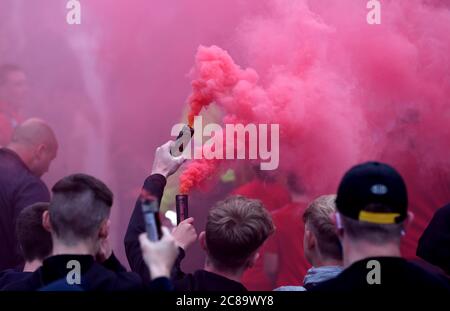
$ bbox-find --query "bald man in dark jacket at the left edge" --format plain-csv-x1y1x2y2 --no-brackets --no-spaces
0,119,58,271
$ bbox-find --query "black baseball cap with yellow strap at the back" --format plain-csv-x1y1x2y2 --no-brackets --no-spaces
336,162,408,224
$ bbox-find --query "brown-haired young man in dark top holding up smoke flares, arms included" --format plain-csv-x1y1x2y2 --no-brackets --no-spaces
124,142,274,291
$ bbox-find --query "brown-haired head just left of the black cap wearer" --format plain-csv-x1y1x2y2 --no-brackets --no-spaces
303,195,342,261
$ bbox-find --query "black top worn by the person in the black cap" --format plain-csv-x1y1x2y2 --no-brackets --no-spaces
310,257,450,293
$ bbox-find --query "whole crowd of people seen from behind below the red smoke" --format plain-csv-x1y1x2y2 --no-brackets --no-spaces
0,66,450,292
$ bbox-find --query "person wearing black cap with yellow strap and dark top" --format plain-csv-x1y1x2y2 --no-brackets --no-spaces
311,162,450,298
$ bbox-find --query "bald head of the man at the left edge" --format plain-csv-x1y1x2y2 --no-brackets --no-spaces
8,118,58,176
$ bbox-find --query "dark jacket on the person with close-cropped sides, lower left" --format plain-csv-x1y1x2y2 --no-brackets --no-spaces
5,254,171,291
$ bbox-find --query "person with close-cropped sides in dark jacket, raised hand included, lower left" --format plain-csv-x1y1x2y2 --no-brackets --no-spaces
5,174,178,291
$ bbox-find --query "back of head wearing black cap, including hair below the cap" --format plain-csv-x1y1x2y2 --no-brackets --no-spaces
336,162,408,245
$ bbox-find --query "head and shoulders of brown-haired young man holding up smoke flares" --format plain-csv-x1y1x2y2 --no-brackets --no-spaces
174,196,274,291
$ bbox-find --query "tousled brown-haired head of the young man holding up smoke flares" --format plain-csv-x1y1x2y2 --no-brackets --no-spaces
205,196,274,270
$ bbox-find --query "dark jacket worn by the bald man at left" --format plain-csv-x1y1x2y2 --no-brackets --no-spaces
0,148,50,271
